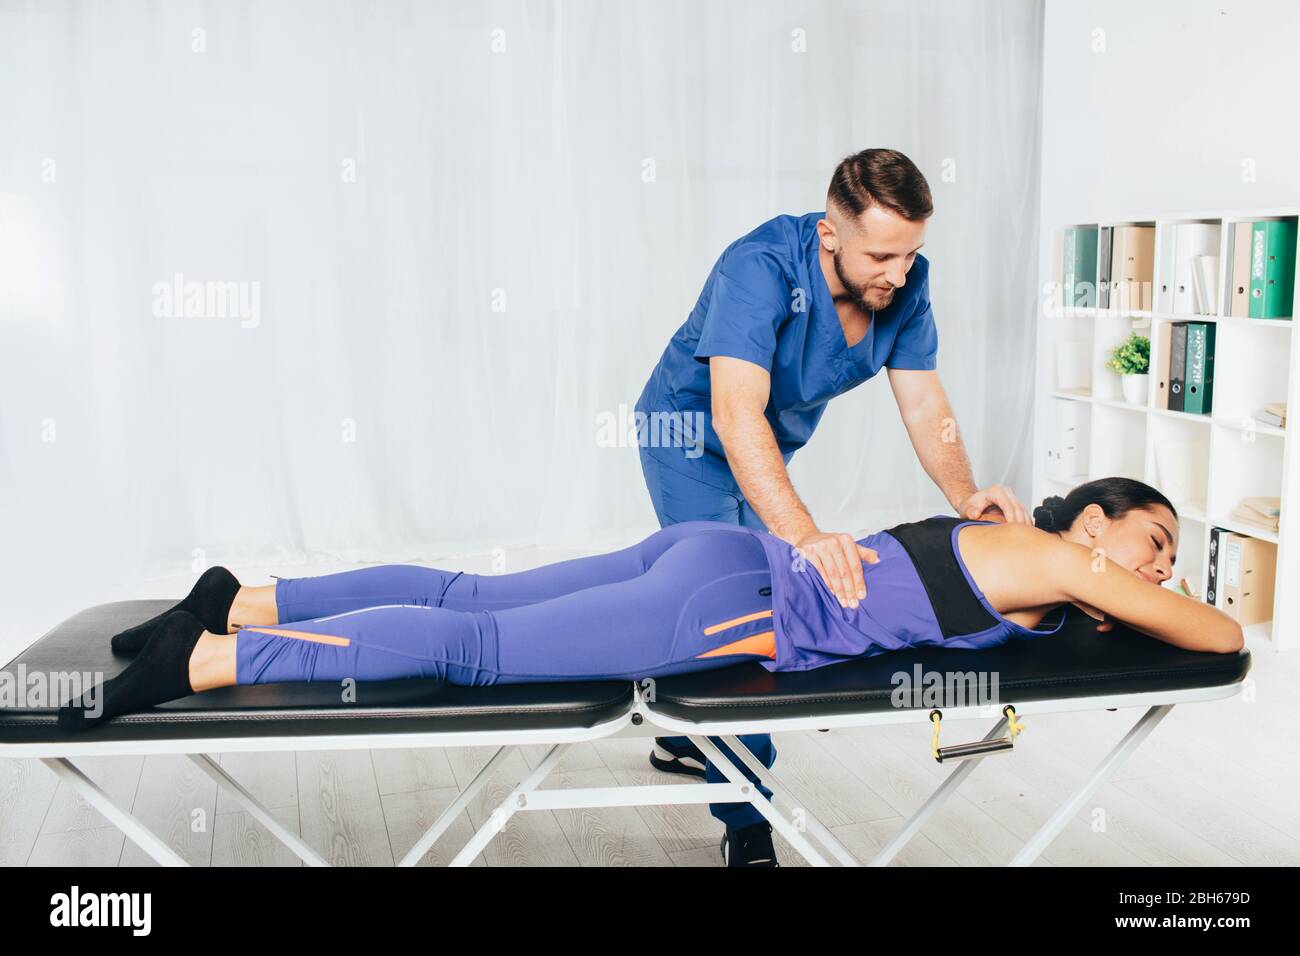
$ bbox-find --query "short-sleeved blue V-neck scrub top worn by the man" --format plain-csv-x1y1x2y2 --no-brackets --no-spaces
636,212,939,486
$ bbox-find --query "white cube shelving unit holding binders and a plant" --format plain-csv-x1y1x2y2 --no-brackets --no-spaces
1034,207,1300,650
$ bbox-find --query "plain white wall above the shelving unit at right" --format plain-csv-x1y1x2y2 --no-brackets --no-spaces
1035,0,1300,502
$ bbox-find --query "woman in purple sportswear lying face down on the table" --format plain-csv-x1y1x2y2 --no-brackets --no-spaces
59,477,1243,728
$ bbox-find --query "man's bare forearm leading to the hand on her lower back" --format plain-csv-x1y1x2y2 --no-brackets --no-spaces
714,415,816,544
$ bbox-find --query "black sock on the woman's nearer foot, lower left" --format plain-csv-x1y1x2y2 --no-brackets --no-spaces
59,611,204,731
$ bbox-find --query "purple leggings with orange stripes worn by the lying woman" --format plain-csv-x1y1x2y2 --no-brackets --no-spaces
235,522,775,685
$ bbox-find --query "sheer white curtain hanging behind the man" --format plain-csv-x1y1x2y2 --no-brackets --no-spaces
0,0,1043,647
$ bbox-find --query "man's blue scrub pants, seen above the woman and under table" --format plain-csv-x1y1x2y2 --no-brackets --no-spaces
640,445,776,829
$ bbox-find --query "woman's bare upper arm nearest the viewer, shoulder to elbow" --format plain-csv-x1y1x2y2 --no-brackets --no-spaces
1019,528,1245,654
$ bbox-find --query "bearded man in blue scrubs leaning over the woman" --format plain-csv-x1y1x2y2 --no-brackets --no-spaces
636,150,1032,866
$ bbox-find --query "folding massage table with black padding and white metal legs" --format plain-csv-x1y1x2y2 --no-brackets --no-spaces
0,601,1251,866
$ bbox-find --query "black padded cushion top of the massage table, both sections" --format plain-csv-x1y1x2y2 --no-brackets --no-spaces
0,601,1251,743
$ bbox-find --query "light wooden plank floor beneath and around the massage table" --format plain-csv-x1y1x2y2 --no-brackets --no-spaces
0,553,1300,866
